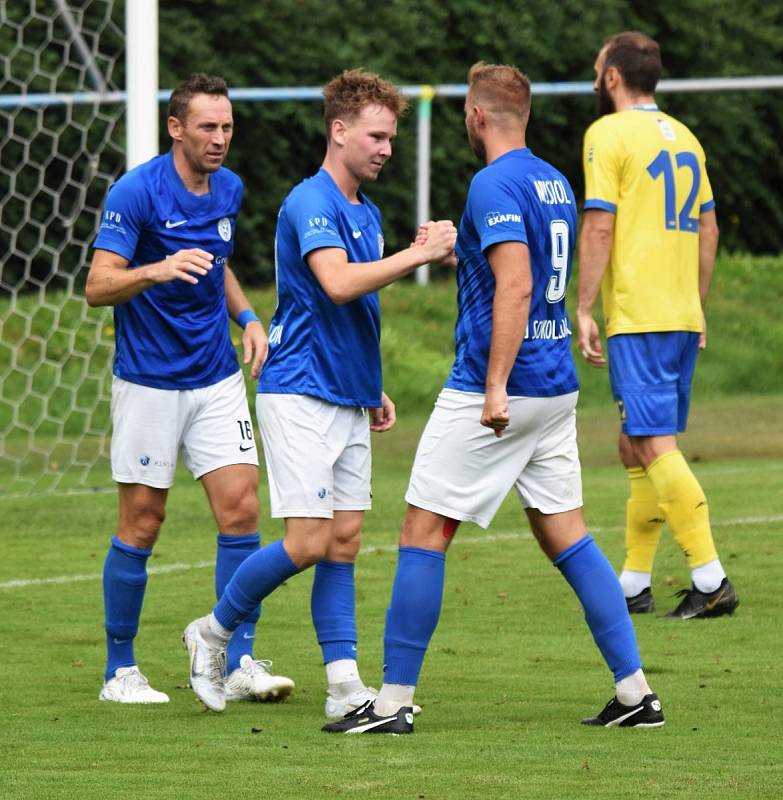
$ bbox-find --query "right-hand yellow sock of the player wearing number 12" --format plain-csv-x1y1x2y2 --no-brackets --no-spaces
648,450,718,569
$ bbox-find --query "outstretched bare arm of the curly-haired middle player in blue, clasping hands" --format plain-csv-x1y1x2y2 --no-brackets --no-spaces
305,220,457,305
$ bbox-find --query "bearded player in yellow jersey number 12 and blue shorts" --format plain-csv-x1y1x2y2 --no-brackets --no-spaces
576,32,739,619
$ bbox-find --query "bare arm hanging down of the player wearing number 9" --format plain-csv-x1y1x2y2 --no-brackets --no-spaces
481,242,533,437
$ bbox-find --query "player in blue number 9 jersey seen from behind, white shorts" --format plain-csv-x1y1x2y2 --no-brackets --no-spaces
323,63,664,734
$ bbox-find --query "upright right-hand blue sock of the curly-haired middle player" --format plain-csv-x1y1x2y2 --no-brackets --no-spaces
310,561,357,664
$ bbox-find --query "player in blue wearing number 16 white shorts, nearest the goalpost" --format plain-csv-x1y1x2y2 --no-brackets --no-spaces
86,74,294,703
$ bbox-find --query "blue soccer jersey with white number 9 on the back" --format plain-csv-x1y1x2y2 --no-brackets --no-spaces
446,148,579,397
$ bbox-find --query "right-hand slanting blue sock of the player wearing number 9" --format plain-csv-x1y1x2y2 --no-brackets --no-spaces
554,536,642,683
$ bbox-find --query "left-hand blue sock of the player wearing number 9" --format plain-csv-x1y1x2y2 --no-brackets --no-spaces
383,547,448,686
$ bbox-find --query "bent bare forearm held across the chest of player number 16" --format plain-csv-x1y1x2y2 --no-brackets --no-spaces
84,247,212,306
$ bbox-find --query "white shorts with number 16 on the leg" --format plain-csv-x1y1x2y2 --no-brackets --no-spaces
111,372,258,489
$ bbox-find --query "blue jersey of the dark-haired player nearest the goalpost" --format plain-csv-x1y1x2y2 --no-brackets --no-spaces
94,153,243,389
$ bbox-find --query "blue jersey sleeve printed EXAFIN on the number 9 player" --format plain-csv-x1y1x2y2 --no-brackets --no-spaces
466,169,527,253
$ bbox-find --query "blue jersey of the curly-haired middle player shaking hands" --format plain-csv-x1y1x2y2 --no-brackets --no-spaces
258,169,383,408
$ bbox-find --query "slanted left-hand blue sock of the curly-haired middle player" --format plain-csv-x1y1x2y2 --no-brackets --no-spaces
213,539,301,631
